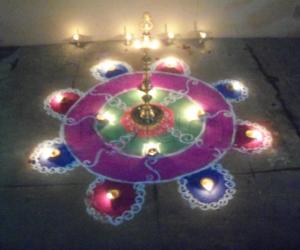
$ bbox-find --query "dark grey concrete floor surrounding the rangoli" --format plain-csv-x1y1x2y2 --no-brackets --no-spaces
0,39,300,250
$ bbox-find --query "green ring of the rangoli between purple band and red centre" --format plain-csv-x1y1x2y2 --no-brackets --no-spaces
95,88,205,157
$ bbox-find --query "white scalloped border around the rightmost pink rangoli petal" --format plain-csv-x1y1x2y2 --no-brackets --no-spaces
232,120,273,154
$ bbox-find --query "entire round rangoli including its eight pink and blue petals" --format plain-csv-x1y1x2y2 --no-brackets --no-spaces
29,52,272,226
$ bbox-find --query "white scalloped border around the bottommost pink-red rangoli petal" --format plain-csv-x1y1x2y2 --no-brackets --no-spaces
84,178,146,226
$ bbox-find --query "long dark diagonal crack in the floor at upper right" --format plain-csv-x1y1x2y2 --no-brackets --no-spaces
246,44,300,138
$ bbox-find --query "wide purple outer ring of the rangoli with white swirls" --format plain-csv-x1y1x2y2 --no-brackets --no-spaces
61,72,236,183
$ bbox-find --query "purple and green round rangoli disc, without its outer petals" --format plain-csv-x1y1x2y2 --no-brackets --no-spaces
62,73,235,183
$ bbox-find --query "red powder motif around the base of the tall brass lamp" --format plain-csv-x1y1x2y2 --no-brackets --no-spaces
121,104,174,137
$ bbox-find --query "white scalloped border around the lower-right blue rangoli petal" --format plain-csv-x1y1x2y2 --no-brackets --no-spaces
177,164,236,211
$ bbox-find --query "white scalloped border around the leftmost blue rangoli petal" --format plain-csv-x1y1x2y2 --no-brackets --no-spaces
29,138,80,174
